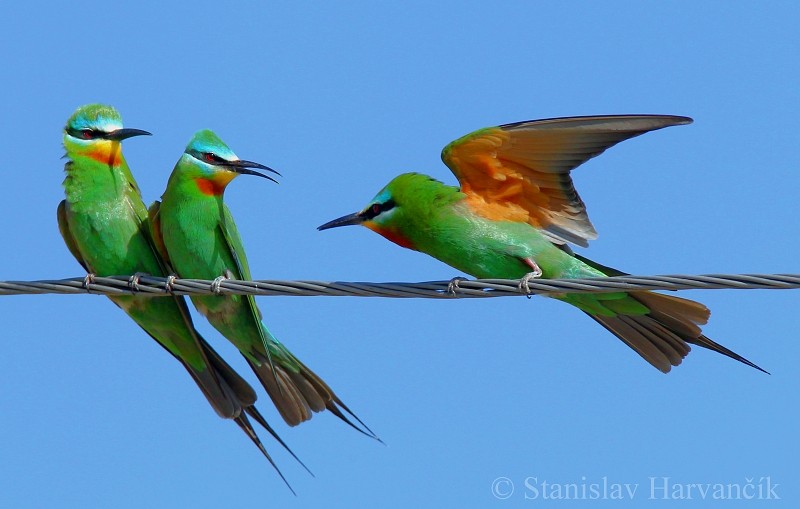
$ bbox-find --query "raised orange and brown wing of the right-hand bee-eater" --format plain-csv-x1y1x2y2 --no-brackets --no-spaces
442,115,692,246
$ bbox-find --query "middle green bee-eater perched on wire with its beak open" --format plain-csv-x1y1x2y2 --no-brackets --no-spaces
150,130,377,438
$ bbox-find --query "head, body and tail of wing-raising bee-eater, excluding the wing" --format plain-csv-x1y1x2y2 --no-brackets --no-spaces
320,171,761,373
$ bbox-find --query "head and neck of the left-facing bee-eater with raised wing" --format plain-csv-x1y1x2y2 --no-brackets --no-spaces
317,173,453,249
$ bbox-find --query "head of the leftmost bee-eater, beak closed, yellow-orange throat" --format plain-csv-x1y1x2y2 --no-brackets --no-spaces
64,104,150,165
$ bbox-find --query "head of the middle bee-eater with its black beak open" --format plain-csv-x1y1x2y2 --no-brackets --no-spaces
176,129,280,196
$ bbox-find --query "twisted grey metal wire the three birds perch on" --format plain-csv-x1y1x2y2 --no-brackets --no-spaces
0,274,800,299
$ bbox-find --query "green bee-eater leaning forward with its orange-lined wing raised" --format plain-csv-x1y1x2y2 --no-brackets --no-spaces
319,115,763,373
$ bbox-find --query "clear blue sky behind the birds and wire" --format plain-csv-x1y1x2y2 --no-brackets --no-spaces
0,1,800,508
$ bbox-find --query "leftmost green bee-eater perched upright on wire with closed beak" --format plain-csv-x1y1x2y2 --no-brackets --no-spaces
58,104,299,481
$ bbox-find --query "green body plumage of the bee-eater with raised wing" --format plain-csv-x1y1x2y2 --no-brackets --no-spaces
362,173,649,316
